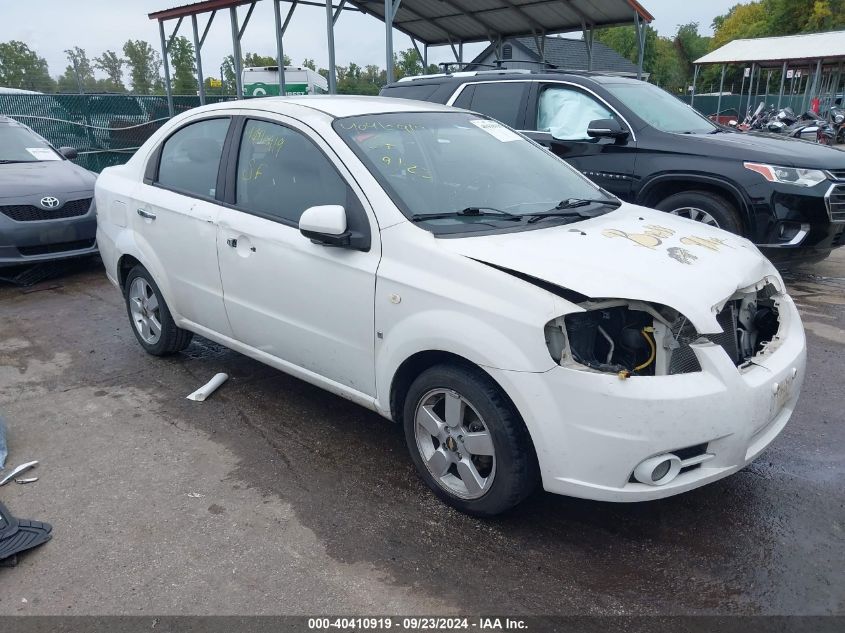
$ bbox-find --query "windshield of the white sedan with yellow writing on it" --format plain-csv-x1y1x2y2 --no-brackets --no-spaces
334,112,615,232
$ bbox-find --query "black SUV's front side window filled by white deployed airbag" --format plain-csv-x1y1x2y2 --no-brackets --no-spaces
537,86,616,141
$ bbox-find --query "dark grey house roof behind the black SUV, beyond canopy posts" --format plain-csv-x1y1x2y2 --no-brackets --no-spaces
472,37,637,74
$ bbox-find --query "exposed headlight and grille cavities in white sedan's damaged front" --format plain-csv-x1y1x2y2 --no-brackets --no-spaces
545,280,782,379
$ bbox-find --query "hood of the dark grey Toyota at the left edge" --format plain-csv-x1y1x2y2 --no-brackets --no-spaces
0,160,97,198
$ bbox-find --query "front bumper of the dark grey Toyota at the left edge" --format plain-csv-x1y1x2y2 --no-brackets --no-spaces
0,194,97,267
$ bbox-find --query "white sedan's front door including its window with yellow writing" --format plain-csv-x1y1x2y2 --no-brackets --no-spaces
218,119,380,396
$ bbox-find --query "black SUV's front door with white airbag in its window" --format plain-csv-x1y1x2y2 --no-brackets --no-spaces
526,83,636,199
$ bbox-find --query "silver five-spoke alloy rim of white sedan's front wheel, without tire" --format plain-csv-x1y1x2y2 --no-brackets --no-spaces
414,389,496,499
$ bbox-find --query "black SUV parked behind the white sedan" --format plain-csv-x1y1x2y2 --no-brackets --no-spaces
381,70,845,260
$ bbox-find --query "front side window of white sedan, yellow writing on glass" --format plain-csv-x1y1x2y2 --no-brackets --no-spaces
235,121,347,224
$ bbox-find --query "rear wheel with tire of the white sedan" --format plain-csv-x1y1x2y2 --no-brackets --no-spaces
124,265,194,356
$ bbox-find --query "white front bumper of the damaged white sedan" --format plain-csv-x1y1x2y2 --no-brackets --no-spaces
487,297,806,501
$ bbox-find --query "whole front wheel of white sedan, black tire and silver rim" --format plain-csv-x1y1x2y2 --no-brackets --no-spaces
403,364,538,516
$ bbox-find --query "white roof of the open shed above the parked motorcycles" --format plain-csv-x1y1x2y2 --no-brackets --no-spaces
693,31,845,66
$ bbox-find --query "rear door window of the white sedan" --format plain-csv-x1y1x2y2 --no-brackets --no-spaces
157,118,229,198
